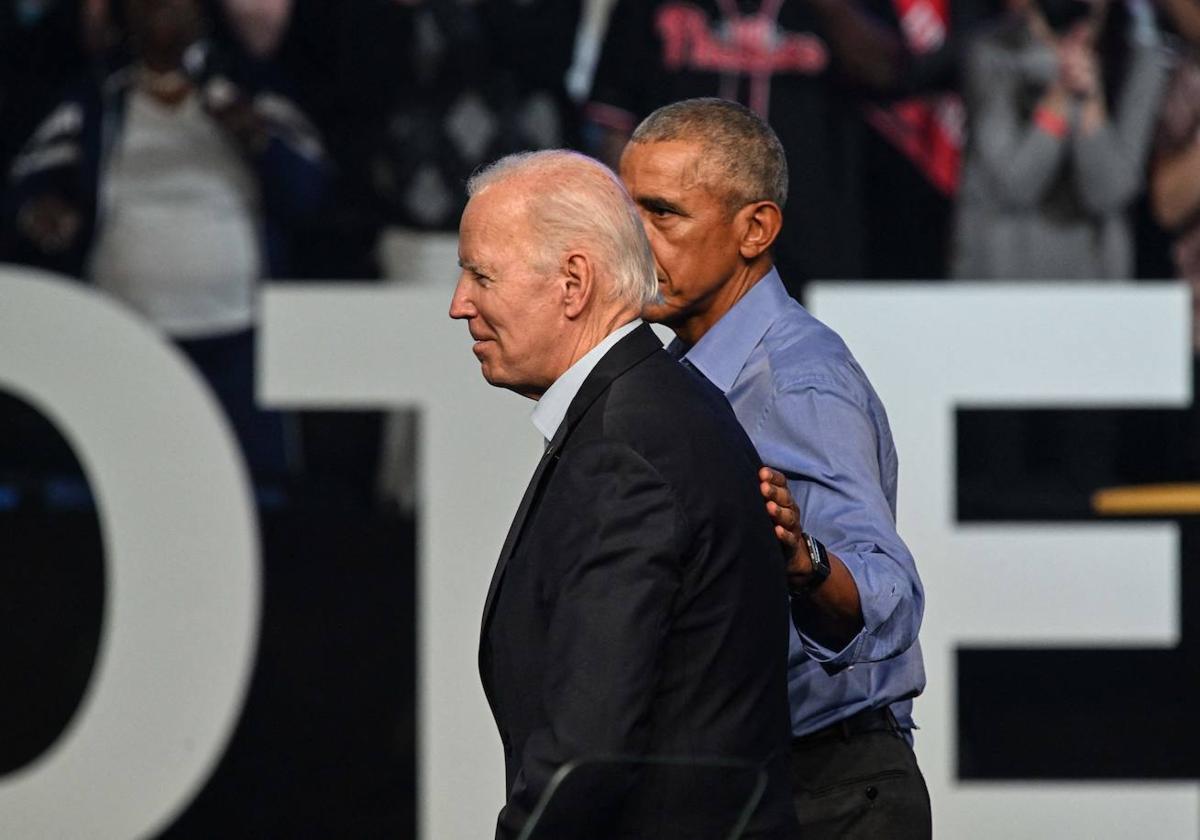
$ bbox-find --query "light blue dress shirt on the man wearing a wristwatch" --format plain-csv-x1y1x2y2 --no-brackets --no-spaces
670,270,925,736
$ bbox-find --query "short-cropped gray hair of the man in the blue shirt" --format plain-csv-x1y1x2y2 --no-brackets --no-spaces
630,97,787,209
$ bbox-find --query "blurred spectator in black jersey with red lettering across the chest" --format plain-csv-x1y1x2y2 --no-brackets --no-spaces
584,0,904,295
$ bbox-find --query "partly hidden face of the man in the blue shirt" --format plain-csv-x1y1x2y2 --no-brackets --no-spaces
620,140,739,326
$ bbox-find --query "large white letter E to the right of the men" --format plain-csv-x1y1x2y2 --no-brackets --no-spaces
812,283,1200,840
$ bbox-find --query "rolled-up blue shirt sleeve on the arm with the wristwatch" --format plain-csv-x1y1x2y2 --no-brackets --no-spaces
755,371,924,672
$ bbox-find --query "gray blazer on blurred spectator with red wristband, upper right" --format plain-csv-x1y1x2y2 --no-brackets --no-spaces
952,24,1168,280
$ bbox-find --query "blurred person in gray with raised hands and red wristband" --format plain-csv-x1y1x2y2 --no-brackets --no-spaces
953,0,1168,280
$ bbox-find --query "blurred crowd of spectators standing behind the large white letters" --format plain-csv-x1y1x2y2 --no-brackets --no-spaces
0,0,1200,506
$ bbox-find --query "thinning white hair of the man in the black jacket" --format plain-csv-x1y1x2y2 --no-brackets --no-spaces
467,149,659,311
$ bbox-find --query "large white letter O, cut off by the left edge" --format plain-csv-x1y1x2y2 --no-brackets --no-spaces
0,266,259,840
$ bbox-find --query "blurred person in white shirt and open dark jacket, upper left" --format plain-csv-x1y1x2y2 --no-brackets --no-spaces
5,0,329,476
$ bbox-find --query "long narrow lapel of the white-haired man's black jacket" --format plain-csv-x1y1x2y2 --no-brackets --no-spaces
480,324,662,648
